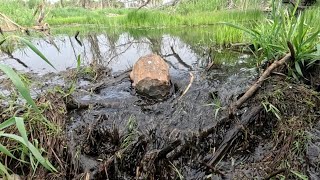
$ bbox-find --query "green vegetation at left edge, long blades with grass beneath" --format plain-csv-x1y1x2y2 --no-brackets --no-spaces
0,36,60,179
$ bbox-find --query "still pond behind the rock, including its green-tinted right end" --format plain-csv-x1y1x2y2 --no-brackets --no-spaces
3,28,252,74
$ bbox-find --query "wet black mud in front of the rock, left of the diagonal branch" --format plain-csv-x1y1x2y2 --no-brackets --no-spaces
67,61,256,179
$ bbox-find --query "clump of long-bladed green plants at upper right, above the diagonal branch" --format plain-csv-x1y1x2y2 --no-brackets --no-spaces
223,0,320,78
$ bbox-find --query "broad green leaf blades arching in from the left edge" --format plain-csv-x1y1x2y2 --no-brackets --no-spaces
0,36,57,178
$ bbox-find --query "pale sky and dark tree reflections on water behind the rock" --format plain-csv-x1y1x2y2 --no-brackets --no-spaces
0,33,251,74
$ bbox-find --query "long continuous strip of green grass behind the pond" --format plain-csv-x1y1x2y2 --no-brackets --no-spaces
47,8,263,28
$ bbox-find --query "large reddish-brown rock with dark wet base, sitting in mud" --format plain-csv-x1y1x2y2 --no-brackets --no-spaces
130,54,170,99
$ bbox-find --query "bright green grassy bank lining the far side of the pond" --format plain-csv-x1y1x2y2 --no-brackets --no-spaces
0,0,264,44
